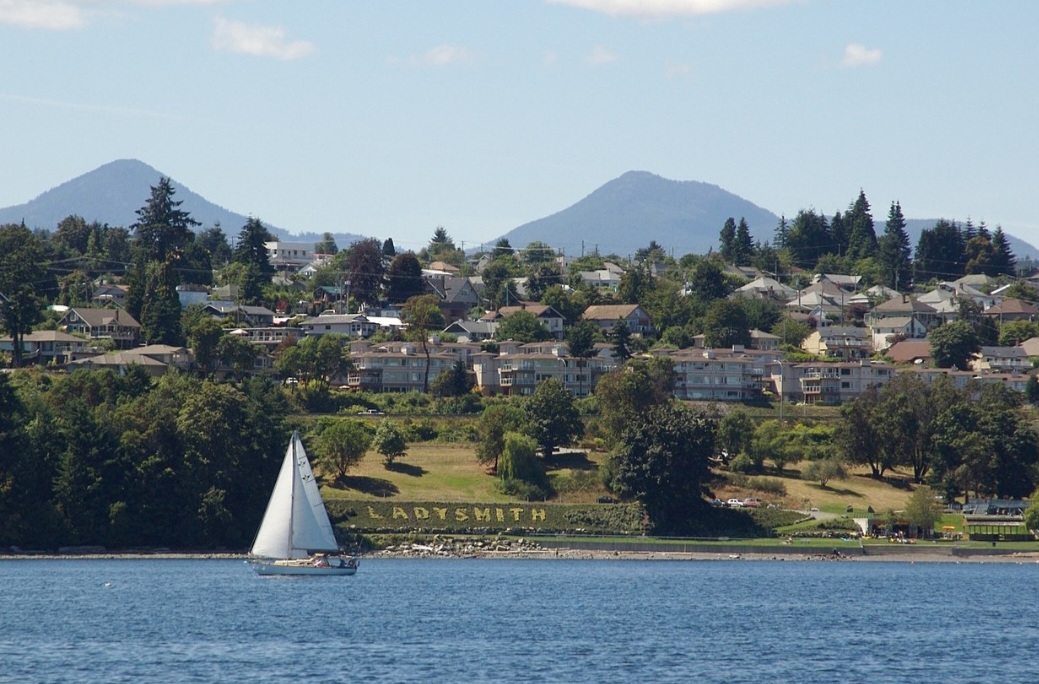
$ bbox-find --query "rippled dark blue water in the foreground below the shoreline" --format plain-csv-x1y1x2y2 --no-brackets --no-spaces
0,560,1039,684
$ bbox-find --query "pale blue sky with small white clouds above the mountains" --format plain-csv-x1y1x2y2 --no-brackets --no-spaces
0,0,1039,251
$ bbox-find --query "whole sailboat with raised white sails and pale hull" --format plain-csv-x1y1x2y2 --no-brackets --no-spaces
249,431,357,575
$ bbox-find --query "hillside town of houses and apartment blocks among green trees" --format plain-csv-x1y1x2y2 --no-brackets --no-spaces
6,185,1039,405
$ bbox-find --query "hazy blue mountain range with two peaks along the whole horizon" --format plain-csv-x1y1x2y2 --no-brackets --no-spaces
0,159,1039,260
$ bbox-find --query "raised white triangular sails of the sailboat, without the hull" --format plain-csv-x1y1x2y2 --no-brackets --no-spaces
251,432,339,558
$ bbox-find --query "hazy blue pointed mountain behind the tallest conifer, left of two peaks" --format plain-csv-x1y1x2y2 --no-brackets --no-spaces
0,159,363,246
